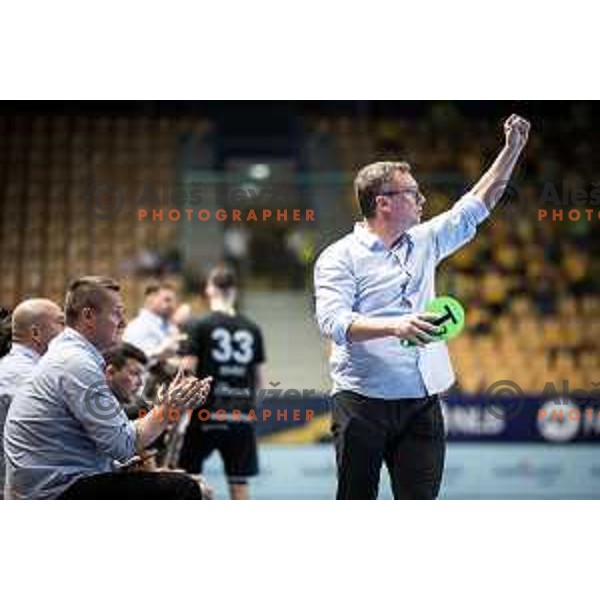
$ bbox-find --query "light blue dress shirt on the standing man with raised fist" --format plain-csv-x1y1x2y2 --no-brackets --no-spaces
314,195,489,400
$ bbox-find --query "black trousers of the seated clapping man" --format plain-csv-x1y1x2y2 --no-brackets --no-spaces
59,471,202,500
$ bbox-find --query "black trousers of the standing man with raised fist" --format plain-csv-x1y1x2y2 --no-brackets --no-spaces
332,391,446,500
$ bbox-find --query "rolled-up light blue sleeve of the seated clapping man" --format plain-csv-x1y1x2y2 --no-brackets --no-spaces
61,359,136,462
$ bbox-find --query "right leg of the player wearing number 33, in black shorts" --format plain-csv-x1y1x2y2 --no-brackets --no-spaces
219,423,258,500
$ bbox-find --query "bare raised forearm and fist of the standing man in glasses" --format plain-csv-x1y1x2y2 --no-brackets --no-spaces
470,115,530,210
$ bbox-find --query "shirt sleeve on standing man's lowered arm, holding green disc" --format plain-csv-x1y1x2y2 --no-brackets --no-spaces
314,247,358,346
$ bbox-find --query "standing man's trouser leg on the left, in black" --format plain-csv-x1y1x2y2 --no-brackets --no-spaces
331,392,387,500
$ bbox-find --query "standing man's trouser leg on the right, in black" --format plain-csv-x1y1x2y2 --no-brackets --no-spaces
385,397,446,500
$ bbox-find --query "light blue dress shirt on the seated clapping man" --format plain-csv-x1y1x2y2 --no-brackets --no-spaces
4,327,136,498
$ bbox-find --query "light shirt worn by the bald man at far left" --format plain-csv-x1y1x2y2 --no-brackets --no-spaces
0,342,40,498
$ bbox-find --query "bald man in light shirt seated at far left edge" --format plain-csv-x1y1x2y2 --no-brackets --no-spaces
0,298,65,499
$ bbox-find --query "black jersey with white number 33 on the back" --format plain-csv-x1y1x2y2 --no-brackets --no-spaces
184,311,265,414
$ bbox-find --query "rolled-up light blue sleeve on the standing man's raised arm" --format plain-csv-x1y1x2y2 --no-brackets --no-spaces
426,194,490,263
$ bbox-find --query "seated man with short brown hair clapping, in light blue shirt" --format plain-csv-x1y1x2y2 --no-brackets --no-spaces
4,277,210,499
